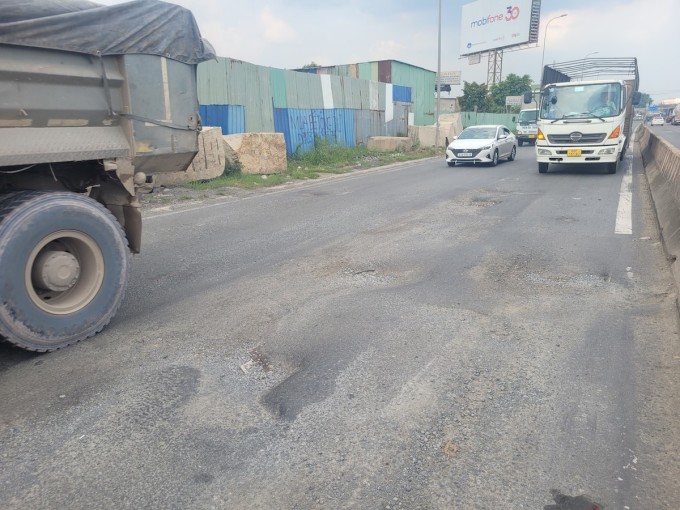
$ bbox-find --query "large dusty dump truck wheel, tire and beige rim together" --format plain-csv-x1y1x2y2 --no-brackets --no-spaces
0,191,130,352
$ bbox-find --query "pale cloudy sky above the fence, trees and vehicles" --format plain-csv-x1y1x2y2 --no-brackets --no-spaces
95,0,680,103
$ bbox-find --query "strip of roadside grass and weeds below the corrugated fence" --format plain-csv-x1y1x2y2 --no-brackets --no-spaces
186,140,442,190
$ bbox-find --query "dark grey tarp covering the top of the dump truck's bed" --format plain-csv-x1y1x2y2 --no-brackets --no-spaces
0,0,215,64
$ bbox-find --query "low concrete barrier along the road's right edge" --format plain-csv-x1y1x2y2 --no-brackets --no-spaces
636,125,680,294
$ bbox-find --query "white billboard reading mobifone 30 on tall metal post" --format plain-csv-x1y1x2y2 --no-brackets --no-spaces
460,0,541,57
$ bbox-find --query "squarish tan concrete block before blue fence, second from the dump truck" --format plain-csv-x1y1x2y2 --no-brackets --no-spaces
223,133,288,175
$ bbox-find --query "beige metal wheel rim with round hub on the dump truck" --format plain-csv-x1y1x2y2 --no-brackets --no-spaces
24,230,104,315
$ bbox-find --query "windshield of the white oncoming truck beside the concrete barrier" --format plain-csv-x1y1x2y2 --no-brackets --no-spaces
541,83,621,119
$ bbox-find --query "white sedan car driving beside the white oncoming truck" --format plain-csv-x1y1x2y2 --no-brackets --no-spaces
446,125,517,166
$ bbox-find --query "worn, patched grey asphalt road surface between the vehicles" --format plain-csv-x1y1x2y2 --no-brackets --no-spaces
0,137,680,510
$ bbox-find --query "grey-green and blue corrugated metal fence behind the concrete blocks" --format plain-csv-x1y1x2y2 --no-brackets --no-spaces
198,58,412,154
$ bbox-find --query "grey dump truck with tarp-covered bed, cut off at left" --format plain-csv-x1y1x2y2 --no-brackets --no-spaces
0,0,214,352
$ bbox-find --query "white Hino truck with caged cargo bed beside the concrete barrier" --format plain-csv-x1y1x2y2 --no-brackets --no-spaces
524,58,640,174
